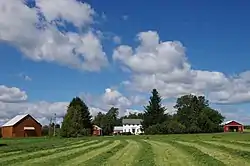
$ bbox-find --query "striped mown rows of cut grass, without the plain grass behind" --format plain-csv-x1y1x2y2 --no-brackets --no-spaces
0,137,250,166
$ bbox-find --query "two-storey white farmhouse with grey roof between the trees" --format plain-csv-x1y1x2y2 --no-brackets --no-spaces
122,119,142,135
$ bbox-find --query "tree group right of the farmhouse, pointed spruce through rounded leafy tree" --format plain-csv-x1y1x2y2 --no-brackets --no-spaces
142,89,225,134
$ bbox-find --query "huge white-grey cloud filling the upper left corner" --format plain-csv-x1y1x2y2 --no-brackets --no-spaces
0,0,108,71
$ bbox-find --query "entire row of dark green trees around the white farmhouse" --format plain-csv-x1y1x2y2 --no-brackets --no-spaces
60,89,224,137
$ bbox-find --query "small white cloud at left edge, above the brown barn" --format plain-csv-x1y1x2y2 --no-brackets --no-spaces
0,85,28,103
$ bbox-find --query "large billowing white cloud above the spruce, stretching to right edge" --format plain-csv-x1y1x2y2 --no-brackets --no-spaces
113,31,250,104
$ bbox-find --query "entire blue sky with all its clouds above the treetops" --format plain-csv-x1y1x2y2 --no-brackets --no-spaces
0,0,250,124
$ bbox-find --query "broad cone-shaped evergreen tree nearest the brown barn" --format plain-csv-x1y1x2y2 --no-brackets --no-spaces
60,97,92,137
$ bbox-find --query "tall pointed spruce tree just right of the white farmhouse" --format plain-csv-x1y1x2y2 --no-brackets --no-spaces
142,89,167,130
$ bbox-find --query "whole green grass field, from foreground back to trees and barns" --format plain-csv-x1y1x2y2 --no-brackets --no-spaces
0,133,250,166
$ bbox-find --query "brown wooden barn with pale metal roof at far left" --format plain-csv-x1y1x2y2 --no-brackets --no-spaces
1,114,42,138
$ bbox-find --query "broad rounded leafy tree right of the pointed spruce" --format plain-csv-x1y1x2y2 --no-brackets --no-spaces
175,95,224,133
